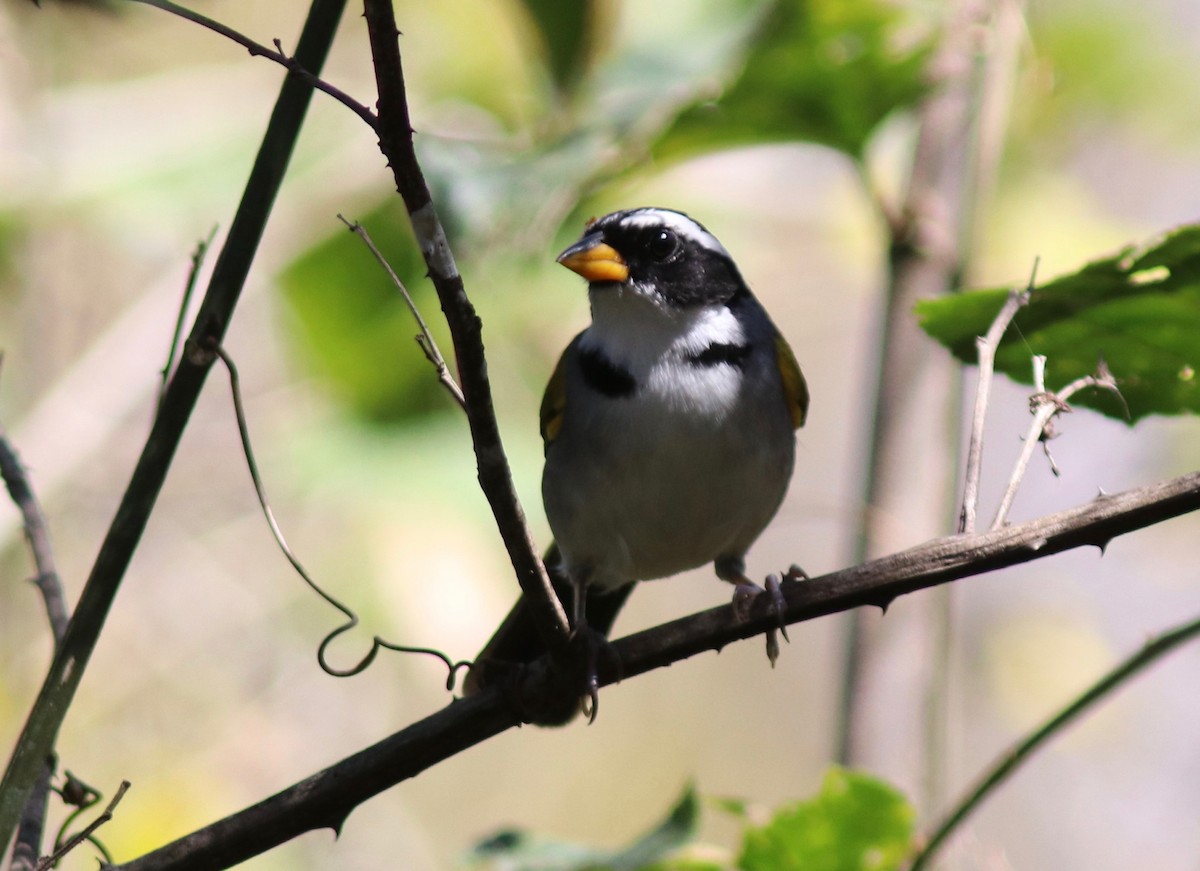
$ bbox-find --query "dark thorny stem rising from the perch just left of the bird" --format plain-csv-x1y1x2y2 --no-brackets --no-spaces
362,0,568,649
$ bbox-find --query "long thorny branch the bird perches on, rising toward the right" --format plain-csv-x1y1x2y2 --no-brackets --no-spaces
110,471,1200,871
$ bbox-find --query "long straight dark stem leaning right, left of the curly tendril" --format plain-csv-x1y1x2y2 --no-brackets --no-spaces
0,0,346,854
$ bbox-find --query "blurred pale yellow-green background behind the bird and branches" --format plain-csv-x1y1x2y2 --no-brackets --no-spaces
0,0,1200,871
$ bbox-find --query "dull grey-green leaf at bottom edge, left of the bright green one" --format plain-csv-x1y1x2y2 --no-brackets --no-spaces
468,786,710,871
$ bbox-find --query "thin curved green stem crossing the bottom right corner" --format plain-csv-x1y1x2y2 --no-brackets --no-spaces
908,619,1200,871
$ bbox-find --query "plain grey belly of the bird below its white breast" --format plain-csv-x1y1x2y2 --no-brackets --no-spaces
542,386,794,588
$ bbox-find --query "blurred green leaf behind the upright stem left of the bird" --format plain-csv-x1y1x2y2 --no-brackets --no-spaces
280,197,450,424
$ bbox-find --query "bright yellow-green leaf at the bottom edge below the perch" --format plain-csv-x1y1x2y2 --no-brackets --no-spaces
738,768,916,871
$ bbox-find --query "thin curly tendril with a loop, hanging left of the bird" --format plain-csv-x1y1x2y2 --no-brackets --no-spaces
214,347,470,690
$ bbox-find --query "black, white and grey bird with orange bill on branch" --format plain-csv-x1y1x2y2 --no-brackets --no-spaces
468,209,809,715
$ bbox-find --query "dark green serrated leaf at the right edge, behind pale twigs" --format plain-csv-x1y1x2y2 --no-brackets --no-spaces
917,224,1200,424
